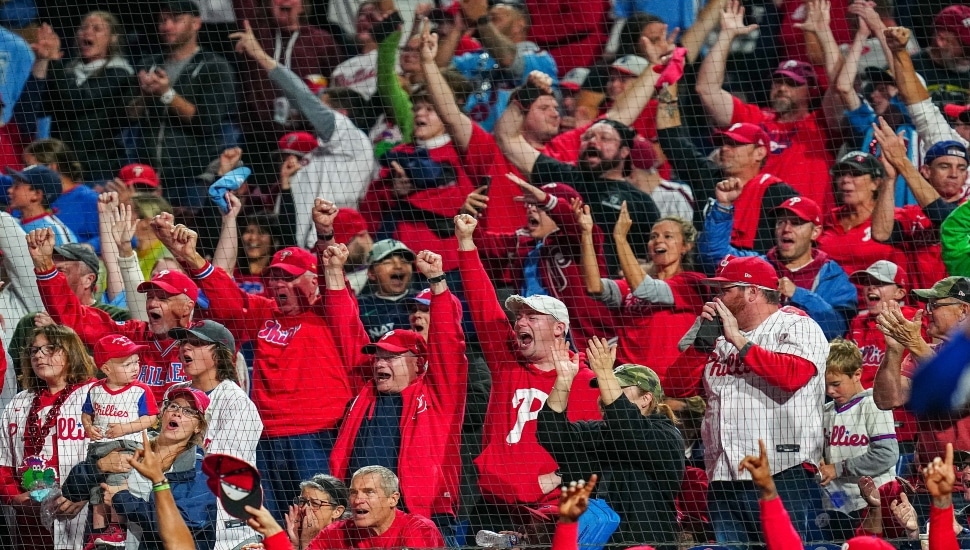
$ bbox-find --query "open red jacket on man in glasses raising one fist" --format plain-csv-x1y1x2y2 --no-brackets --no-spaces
330,292,468,517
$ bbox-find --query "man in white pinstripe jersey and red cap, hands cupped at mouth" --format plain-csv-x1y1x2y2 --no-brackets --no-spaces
666,257,829,544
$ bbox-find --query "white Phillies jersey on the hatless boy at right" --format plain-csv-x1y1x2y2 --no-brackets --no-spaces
822,389,898,514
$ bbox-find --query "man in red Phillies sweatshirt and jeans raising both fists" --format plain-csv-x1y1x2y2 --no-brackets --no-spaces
149,199,369,517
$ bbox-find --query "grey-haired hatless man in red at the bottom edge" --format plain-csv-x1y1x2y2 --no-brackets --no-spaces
307,466,445,550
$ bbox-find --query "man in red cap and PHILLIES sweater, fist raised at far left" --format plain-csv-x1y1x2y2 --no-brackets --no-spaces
27,228,191,402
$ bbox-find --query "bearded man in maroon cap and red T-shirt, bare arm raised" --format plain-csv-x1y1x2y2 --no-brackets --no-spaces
697,2,835,212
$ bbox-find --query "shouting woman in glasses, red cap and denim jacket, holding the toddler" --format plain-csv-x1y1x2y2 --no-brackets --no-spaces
64,388,216,550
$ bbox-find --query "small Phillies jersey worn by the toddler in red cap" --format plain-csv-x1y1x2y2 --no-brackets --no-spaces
81,379,158,443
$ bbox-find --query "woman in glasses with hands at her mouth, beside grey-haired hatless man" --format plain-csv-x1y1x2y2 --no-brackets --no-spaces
286,474,350,550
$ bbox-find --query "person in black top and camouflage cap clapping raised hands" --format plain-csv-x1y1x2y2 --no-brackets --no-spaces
536,337,684,549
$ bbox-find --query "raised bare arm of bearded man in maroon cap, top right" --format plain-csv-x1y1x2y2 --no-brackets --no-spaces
697,0,758,127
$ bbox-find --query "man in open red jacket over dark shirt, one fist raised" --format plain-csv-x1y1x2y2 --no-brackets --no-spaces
330,250,468,546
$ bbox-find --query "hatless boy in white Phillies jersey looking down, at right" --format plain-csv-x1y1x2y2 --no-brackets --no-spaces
819,338,899,540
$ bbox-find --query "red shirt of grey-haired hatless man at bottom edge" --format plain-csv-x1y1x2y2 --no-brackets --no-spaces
307,510,445,550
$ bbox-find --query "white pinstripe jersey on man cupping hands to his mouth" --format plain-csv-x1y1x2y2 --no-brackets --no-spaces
702,307,829,481
